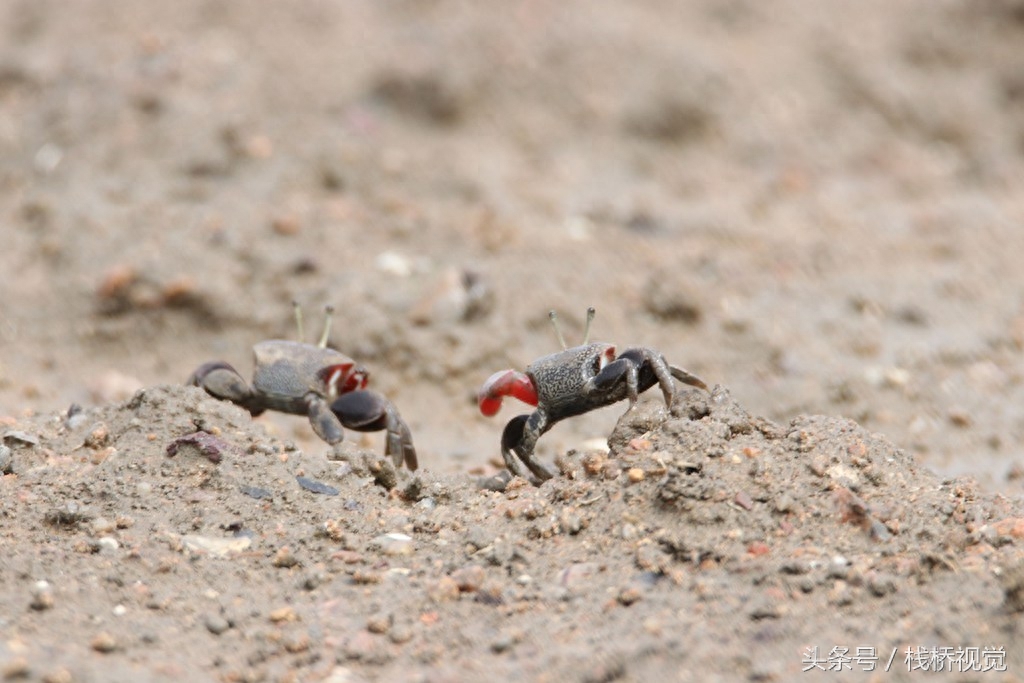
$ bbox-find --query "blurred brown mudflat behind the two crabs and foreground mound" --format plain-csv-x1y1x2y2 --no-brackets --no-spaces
0,0,1024,494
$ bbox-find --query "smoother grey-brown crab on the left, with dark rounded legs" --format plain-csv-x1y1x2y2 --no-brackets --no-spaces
187,304,417,470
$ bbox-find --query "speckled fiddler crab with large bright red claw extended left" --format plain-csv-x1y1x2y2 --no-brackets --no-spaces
477,308,708,483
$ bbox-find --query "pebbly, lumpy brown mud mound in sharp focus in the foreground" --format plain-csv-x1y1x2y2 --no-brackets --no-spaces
0,386,1024,682
